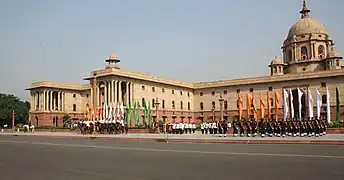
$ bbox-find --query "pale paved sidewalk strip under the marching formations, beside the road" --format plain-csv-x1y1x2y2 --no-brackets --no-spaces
0,132,344,145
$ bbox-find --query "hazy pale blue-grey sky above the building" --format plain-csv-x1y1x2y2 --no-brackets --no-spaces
0,0,344,99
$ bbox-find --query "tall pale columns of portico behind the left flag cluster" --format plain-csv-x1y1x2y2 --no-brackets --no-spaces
91,80,134,106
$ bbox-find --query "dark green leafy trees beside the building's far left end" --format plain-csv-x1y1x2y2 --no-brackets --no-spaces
0,93,30,126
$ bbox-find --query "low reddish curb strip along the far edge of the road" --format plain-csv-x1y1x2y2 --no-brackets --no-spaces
0,134,344,145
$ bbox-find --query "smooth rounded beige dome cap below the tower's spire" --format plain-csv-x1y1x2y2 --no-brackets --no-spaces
287,17,328,39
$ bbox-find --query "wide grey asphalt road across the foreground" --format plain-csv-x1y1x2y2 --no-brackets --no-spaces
0,136,344,180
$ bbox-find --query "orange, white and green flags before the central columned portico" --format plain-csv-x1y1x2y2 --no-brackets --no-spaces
85,102,153,127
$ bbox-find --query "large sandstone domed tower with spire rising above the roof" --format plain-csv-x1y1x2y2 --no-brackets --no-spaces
282,1,341,73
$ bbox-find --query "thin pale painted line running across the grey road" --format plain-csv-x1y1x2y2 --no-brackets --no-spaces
0,140,344,159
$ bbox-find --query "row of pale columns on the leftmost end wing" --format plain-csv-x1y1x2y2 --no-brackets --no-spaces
30,91,65,111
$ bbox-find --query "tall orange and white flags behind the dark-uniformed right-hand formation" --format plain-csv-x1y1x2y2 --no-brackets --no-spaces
237,87,340,122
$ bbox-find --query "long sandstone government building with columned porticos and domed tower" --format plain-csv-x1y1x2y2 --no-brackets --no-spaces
28,2,344,127
